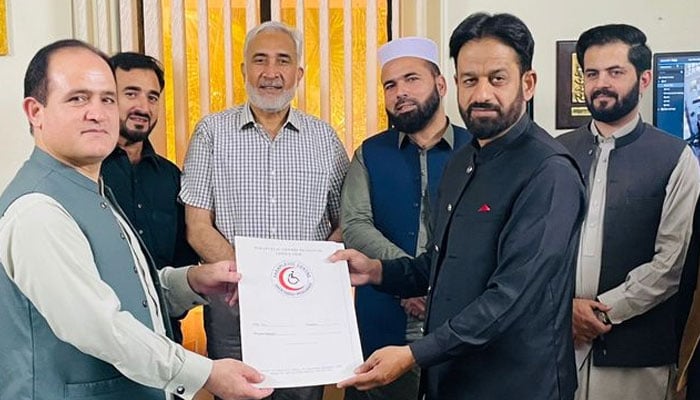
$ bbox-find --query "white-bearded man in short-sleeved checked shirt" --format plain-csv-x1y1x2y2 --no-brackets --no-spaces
180,21,349,400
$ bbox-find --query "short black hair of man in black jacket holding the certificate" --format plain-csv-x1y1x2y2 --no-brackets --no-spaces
450,13,535,74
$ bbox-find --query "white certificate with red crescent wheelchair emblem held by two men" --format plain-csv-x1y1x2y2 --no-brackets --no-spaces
236,236,362,388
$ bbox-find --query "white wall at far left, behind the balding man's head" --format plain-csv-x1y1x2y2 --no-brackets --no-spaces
0,0,71,191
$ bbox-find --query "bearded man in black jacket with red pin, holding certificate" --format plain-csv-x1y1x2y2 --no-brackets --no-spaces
335,14,585,400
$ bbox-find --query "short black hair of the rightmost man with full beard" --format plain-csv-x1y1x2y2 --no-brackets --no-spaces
576,24,651,77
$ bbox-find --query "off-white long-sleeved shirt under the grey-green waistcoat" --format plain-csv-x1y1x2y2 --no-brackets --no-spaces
0,193,212,399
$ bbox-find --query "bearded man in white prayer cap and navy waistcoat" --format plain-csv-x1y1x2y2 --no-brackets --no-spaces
341,37,471,400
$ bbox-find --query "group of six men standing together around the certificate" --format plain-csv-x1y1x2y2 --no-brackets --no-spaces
0,13,700,400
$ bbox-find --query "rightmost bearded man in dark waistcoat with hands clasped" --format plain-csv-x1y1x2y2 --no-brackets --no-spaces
559,25,700,400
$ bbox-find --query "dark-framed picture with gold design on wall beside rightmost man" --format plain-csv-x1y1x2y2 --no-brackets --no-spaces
555,40,591,129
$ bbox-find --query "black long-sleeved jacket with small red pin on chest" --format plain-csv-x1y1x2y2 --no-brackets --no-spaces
381,116,585,400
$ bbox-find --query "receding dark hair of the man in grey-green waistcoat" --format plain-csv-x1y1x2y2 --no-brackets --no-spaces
24,39,114,105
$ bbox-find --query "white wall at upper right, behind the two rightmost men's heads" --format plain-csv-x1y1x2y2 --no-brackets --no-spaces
438,0,700,135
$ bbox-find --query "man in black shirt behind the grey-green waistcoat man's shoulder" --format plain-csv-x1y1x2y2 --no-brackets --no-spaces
100,52,199,343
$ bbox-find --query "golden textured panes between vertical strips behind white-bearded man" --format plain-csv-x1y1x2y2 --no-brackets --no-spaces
161,0,388,161
